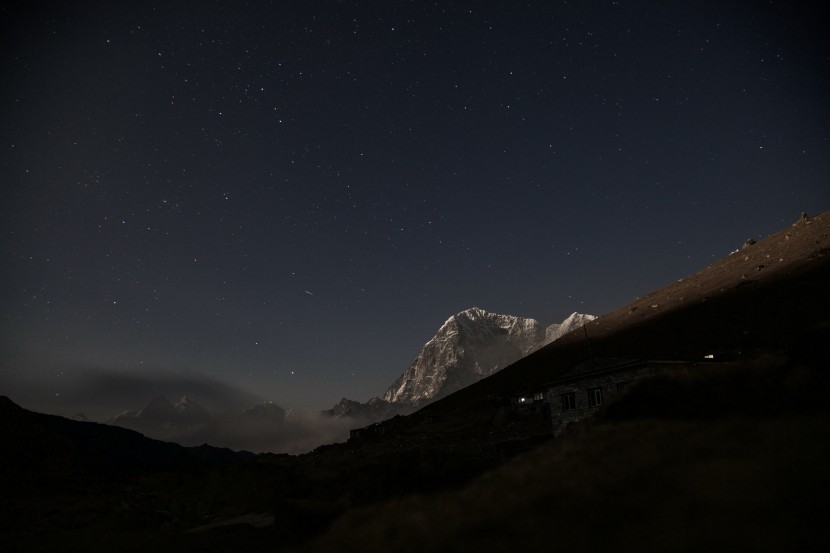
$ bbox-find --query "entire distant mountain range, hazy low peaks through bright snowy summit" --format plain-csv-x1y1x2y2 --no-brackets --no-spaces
104,307,596,438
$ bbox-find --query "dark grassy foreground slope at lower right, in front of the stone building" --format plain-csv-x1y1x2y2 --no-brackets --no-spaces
304,359,830,552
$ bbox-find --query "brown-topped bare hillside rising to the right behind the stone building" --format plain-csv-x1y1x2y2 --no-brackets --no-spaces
426,212,830,410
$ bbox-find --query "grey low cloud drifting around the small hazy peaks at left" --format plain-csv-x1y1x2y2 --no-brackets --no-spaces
4,368,368,454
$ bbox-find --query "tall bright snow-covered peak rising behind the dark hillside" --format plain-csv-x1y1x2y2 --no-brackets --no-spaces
383,307,594,405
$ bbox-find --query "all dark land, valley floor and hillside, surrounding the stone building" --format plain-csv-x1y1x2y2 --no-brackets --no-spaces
0,210,830,552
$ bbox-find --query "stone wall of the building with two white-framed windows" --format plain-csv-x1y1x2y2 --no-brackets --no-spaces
548,365,659,435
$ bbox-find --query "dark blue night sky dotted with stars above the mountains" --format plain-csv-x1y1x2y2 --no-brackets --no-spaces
0,0,830,417
